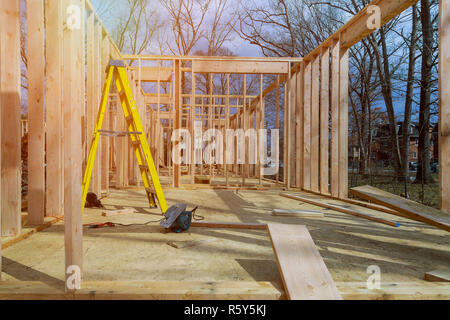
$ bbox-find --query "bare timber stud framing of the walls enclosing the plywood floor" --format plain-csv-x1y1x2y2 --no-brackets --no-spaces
0,0,450,290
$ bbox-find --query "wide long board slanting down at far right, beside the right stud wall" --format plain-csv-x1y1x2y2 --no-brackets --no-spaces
350,186,450,231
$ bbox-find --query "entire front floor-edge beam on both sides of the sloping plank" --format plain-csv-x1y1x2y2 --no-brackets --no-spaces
0,281,450,300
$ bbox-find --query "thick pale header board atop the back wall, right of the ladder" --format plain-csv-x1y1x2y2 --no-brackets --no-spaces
192,60,289,74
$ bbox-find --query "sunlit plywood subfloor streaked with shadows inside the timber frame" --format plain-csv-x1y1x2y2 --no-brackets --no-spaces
2,189,450,298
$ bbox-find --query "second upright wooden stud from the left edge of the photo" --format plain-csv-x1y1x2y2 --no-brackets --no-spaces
26,0,45,226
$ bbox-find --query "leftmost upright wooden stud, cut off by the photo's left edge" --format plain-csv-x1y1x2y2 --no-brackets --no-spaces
0,0,22,237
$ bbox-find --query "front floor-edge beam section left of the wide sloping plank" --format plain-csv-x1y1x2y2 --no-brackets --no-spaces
0,281,285,300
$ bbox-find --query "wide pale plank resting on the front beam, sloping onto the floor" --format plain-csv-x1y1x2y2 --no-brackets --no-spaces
268,224,342,300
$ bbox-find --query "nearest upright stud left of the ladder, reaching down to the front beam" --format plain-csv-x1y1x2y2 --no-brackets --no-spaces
63,0,84,292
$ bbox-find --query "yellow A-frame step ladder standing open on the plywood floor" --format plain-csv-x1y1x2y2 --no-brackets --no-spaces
83,60,168,214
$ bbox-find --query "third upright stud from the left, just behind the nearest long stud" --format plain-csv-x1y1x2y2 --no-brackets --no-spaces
45,0,64,217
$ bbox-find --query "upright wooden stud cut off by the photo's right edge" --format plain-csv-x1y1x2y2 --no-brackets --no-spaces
439,0,450,213
